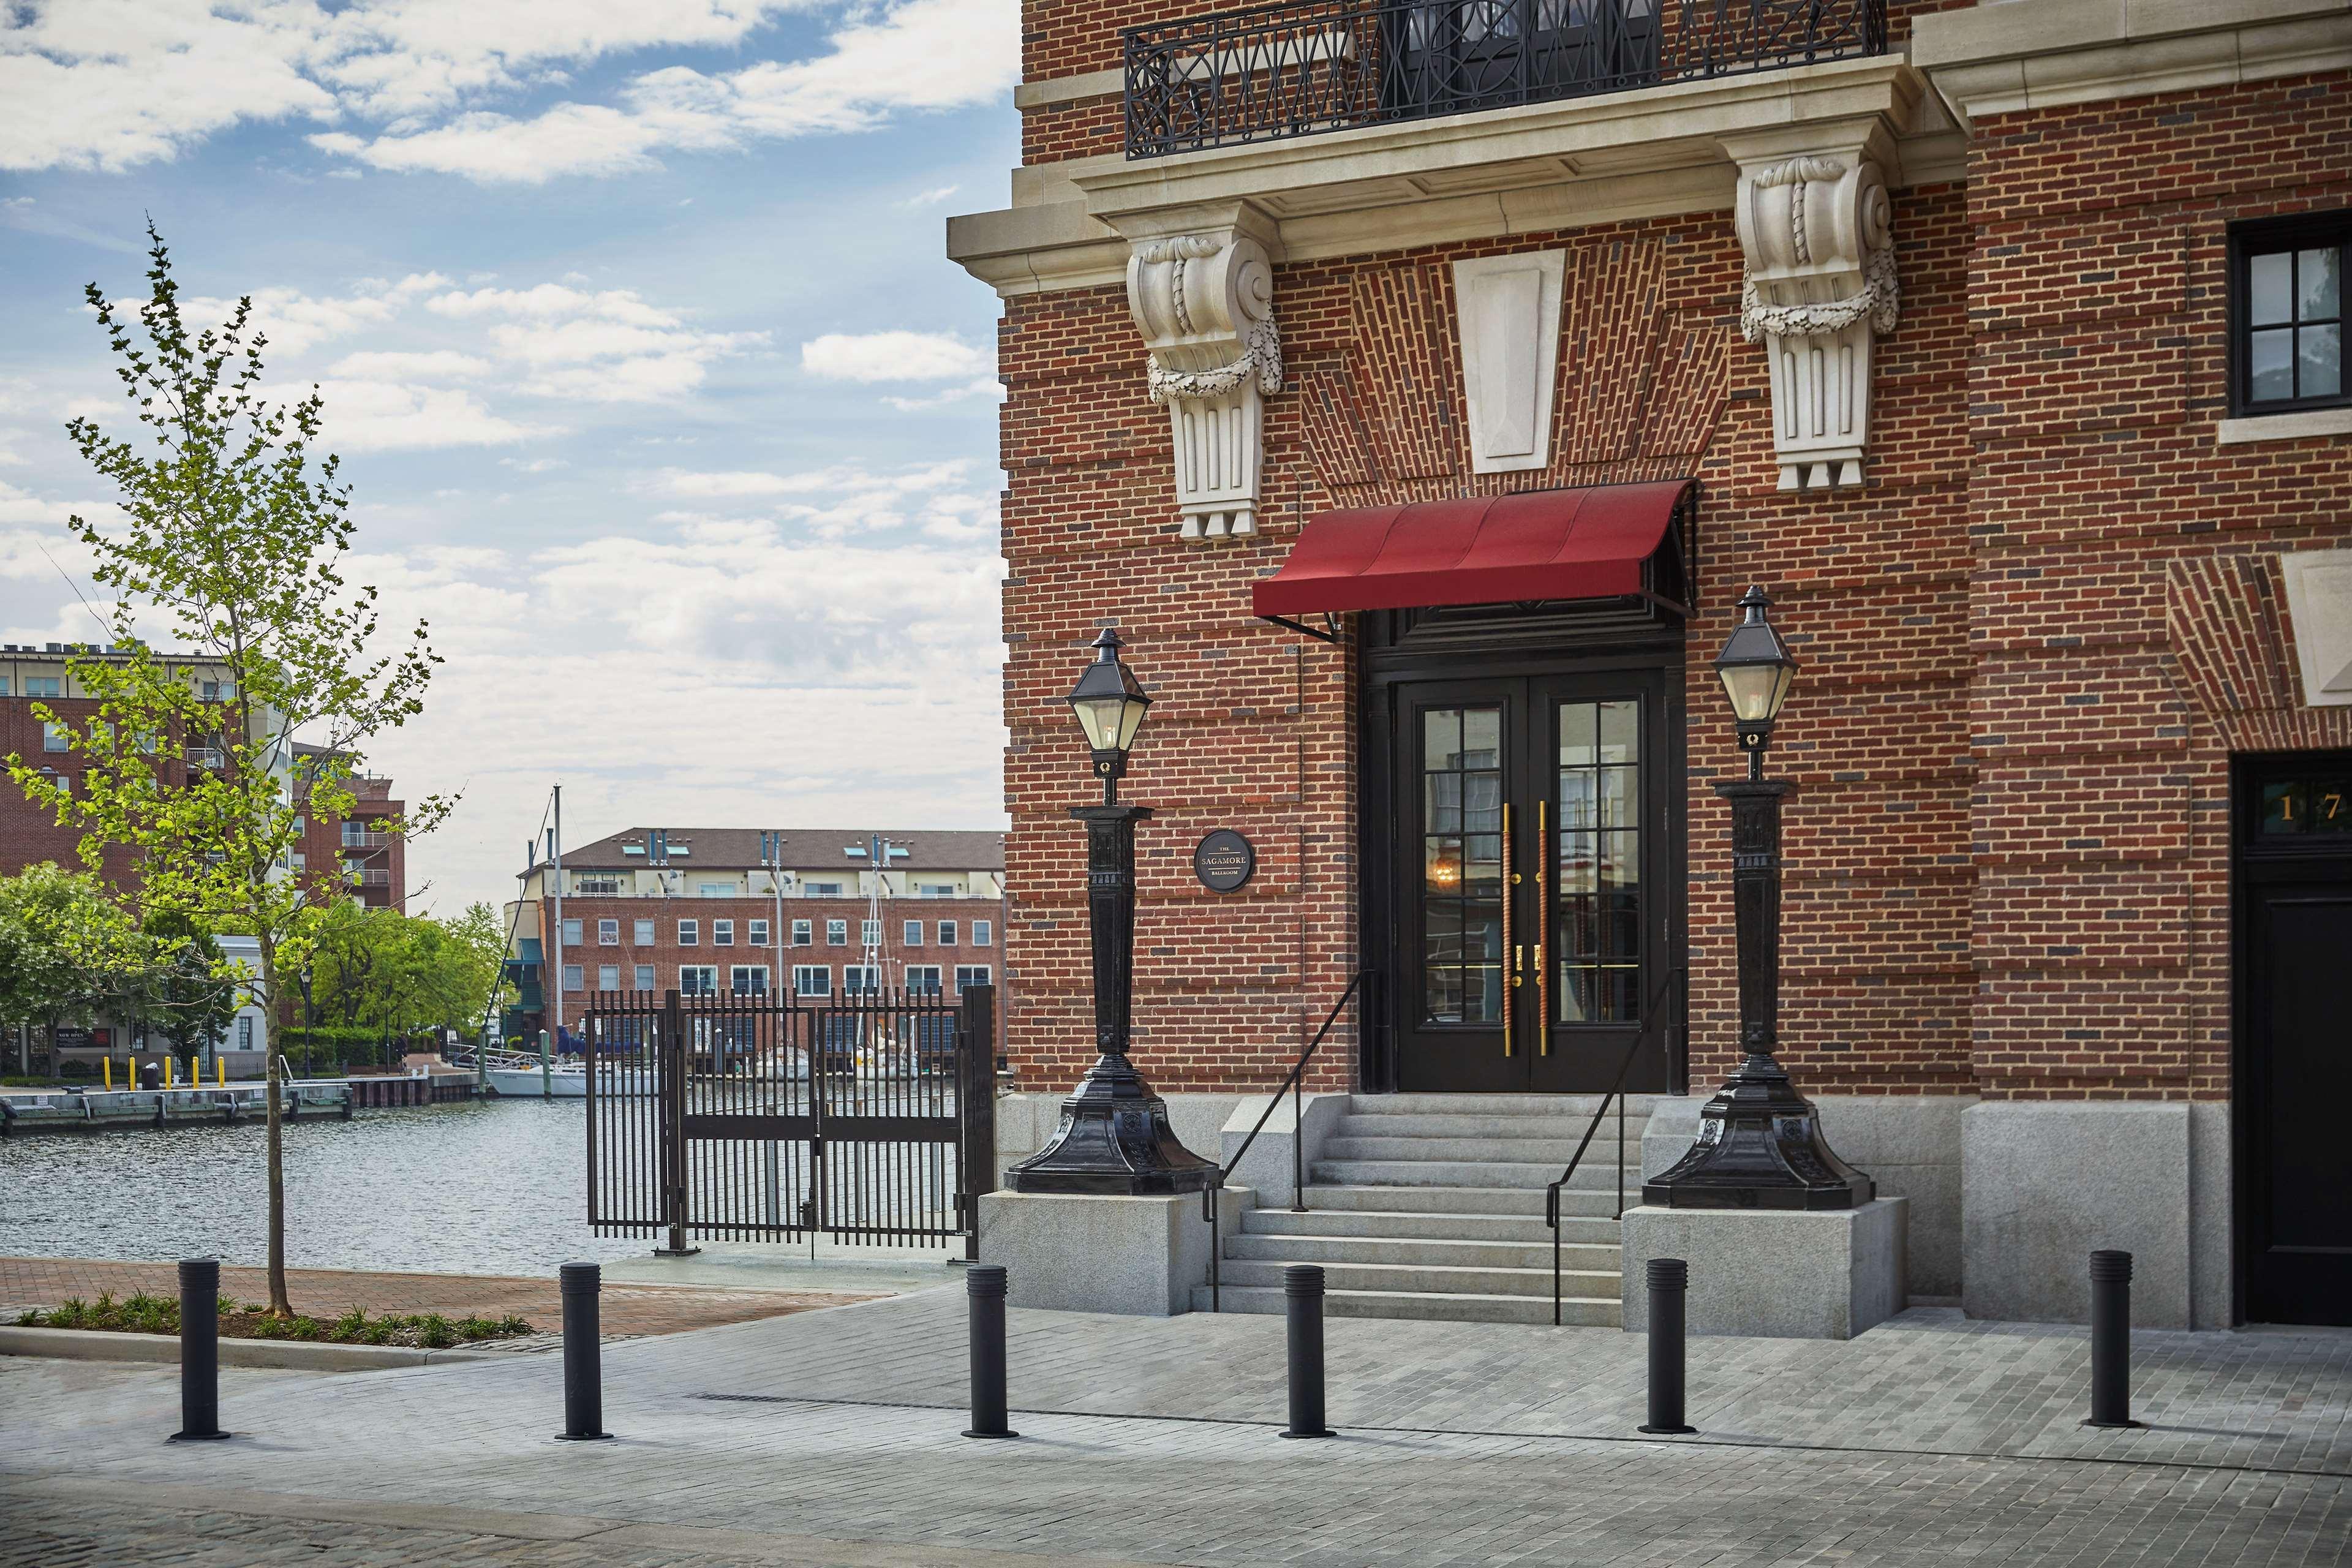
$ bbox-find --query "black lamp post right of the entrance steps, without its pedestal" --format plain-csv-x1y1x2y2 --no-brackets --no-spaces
1642,588,1877,1208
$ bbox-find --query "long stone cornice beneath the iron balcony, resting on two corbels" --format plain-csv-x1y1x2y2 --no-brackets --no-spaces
948,56,1964,296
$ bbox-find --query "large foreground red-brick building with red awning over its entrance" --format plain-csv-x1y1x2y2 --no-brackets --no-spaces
948,0,2352,1326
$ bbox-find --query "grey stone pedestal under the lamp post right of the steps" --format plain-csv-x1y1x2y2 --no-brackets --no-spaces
1623,1199,1910,1340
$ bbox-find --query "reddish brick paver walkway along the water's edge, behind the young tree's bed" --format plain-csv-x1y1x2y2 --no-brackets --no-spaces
0,1257,865,1338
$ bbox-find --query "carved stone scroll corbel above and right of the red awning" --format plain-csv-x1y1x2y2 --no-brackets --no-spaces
1727,134,1901,489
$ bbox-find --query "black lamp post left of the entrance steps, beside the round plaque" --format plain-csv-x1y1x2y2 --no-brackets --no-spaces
1005,630,1218,1197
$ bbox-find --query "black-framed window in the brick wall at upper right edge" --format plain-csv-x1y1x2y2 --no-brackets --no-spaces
2230,211,2352,416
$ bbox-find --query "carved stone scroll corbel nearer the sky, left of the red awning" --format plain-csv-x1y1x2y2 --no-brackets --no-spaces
1126,214,1282,538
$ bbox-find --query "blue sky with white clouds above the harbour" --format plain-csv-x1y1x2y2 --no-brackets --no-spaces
0,0,1019,912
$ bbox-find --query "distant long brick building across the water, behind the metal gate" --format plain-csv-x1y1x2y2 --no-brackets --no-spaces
513,827,1005,1032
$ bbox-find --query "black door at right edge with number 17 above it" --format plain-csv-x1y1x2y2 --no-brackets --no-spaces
2237,752,2352,1326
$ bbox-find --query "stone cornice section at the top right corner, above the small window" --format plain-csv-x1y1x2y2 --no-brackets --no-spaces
1910,0,2352,127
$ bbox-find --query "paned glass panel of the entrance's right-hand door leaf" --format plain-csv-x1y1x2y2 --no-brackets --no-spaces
1552,701,1642,1023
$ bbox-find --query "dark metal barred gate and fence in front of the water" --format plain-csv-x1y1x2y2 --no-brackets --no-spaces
581,985,997,1256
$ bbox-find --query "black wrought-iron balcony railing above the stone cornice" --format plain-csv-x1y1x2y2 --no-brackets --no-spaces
1120,0,1887,157
